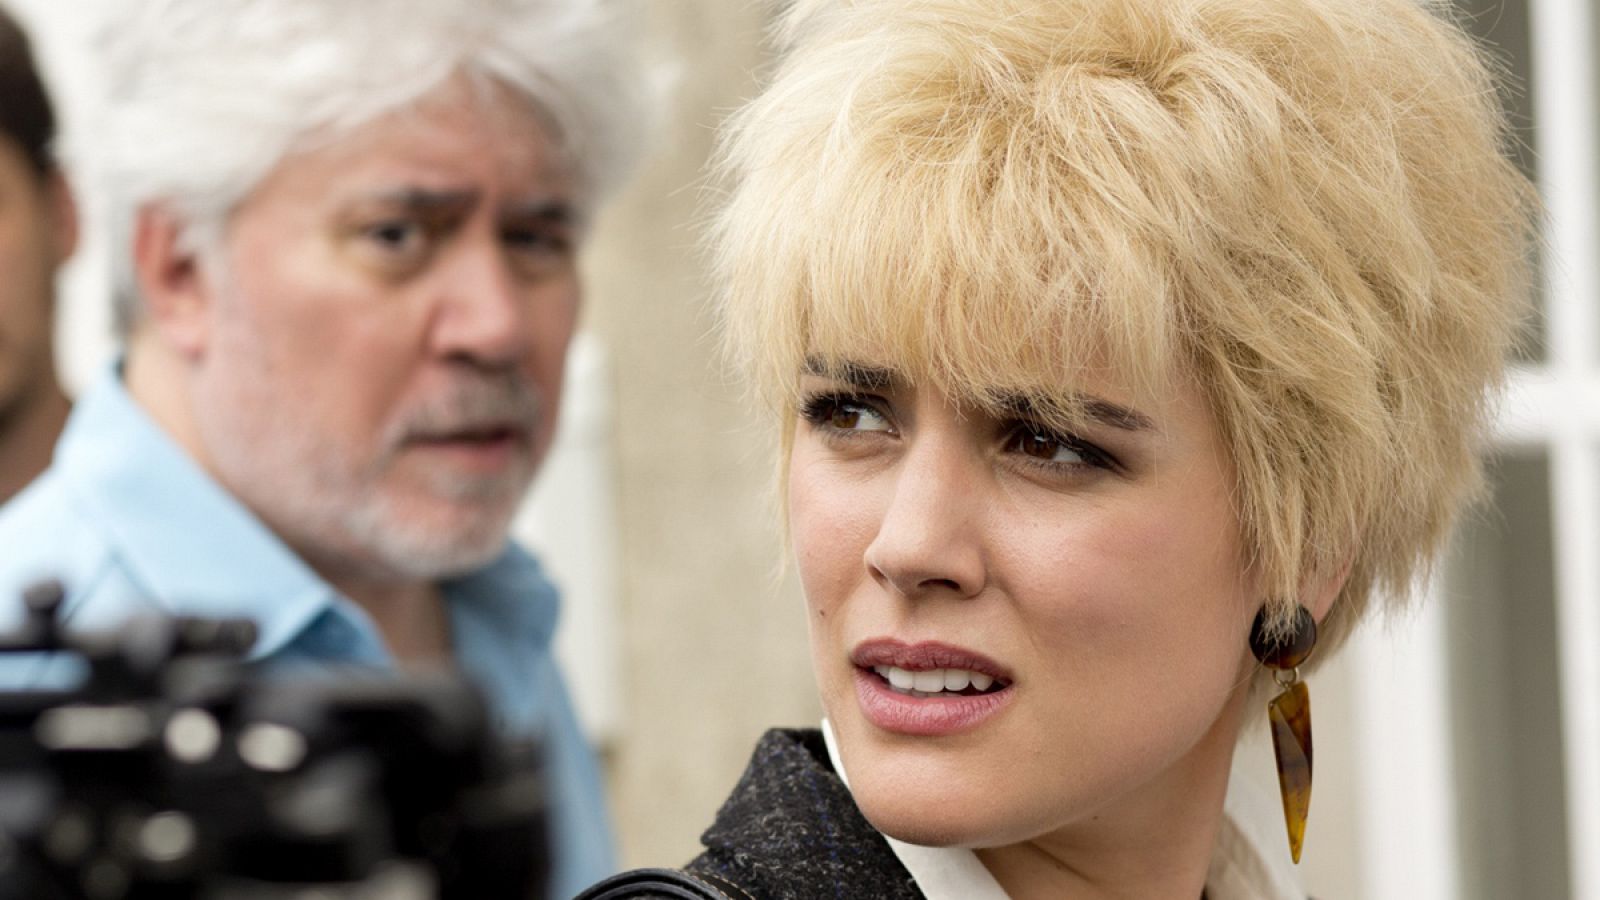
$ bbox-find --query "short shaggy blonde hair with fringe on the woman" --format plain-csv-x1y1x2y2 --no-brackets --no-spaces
710,0,1534,657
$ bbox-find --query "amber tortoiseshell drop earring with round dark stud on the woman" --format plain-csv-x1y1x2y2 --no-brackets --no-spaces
1250,605,1317,865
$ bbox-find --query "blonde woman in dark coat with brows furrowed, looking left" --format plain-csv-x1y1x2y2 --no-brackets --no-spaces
582,0,1530,900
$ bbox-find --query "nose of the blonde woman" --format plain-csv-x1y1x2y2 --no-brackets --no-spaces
866,442,987,599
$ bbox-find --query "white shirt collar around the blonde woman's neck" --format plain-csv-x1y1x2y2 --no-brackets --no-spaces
822,719,1306,900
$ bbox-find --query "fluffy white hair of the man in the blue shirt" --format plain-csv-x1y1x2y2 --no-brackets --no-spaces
70,0,643,336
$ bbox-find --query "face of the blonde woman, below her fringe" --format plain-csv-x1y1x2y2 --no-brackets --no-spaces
789,357,1259,846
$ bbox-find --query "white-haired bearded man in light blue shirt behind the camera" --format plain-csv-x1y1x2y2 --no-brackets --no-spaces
0,0,635,897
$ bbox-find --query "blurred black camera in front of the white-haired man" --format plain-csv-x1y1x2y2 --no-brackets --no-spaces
0,583,549,900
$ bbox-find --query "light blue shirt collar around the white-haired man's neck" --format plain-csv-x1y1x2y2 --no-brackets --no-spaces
53,362,558,679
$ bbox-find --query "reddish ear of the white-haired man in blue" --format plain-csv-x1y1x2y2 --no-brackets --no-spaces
133,205,214,360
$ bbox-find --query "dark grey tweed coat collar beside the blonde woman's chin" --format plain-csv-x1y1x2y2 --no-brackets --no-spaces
686,729,923,900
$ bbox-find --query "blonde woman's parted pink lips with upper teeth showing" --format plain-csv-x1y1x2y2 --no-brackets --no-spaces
850,639,1013,737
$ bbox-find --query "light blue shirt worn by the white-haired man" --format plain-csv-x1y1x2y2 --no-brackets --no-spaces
0,367,614,898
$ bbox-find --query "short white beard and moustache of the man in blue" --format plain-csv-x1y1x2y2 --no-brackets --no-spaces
190,249,554,581
